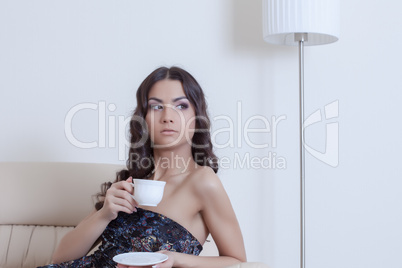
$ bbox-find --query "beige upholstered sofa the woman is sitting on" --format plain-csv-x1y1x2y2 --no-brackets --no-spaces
0,163,267,268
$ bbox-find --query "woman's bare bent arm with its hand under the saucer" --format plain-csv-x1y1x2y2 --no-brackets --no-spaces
166,169,246,268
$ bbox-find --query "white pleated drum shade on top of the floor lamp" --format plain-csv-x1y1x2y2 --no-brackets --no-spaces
262,0,340,46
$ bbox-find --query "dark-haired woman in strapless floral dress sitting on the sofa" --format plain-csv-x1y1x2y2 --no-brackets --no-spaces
42,67,246,268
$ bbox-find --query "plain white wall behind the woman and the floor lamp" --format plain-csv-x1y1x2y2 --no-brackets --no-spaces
0,0,402,268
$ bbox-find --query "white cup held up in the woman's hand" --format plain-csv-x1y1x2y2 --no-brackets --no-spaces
132,179,166,207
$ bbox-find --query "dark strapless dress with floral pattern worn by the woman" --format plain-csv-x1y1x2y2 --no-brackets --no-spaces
38,208,202,268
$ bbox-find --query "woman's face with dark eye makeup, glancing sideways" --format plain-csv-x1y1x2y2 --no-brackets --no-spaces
145,79,195,148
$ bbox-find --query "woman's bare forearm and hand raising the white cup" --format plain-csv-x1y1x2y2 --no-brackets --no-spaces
53,178,137,263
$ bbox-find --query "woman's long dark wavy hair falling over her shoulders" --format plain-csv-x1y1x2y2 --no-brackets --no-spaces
95,67,218,210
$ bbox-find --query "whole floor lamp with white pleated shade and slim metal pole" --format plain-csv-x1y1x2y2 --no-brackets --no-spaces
262,0,340,268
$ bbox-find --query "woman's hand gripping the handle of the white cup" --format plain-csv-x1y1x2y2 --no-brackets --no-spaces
100,177,138,221
